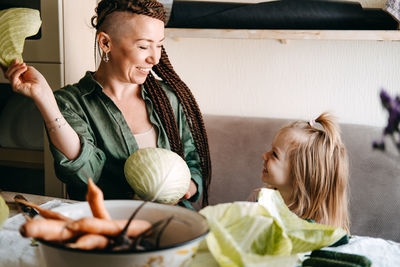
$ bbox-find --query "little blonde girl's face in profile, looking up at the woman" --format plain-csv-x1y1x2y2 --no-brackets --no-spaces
261,129,295,191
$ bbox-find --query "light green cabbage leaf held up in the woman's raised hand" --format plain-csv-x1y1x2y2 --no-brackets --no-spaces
0,8,42,67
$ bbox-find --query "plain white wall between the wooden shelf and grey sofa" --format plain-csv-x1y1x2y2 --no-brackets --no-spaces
165,1,400,126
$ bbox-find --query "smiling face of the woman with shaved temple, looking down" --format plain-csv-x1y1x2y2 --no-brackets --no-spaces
106,12,164,84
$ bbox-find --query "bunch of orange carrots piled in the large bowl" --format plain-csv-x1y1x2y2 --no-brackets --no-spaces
15,178,152,250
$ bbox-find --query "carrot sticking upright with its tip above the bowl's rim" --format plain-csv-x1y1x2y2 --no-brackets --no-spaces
86,177,111,220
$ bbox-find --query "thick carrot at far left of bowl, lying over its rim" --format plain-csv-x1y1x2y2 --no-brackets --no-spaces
19,218,78,241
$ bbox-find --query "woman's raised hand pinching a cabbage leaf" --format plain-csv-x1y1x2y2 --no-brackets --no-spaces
4,60,52,100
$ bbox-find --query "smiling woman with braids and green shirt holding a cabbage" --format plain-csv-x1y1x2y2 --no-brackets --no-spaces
6,0,211,208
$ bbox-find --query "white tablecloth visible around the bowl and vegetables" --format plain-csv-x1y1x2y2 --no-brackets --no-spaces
0,200,400,267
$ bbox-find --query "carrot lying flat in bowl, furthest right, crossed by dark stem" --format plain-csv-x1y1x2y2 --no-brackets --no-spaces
67,217,151,237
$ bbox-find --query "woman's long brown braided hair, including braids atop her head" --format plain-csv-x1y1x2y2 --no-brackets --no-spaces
92,0,211,207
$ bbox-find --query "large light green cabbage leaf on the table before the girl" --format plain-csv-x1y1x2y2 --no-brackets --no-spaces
200,189,346,267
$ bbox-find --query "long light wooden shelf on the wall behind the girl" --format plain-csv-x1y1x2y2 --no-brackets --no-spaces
165,28,400,41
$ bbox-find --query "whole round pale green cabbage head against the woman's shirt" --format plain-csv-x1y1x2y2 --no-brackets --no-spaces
124,148,191,203
